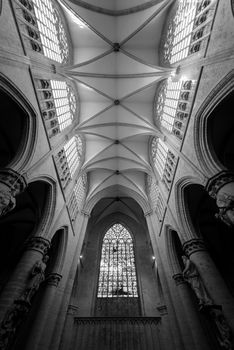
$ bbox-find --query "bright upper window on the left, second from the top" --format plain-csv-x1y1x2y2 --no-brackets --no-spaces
37,80,77,137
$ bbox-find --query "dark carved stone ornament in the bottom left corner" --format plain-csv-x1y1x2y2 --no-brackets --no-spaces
0,300,30,350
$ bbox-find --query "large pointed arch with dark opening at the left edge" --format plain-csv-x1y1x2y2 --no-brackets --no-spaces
0,74,37,172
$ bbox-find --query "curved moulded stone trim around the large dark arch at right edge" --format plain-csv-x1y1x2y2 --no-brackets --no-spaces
194,70,234,177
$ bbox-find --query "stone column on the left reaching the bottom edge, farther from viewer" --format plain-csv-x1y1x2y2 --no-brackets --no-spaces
25,272,62,350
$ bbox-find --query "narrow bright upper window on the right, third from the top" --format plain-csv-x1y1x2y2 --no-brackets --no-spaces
151,137,177,190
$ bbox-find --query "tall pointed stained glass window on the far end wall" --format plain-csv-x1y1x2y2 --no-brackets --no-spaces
97,223,138,298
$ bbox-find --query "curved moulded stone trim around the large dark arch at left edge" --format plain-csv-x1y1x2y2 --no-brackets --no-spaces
0,73,38,172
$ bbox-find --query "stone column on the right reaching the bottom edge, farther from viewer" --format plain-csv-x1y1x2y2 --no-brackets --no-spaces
172,273,210,350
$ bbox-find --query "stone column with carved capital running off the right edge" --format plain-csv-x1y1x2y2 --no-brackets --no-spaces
183,238,234,331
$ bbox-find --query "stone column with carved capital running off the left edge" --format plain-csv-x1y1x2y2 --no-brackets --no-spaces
0,236,50,321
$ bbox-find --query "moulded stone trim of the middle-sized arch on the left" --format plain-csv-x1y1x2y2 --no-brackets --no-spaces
28,175,57,238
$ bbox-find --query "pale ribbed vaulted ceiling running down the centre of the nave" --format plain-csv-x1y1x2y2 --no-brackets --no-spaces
60,0,174,215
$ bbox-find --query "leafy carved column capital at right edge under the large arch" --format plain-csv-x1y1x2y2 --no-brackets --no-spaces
205,171,234,198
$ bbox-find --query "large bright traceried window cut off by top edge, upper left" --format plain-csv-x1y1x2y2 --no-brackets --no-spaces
15,0,69,63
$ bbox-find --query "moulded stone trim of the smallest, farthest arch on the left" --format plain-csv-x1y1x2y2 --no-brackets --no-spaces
48,226,68,275
